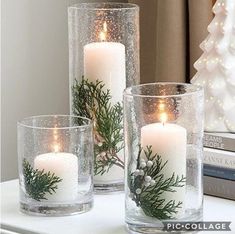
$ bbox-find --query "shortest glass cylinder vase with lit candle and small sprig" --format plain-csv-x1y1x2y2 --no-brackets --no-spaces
18,115,94,216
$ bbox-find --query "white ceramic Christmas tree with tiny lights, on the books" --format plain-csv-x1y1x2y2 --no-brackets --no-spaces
191,0,235,132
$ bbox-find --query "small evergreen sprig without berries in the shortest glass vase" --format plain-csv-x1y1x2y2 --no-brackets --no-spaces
23,159,62,201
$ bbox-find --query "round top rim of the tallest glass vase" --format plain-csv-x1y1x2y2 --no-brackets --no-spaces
68,2,139,11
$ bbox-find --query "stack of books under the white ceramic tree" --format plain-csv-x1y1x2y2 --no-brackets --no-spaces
204,132,235,200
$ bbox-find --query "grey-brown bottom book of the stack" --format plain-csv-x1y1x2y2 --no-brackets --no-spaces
204,176,235,200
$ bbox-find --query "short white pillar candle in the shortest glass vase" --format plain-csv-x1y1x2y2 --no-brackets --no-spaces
34,152,78,202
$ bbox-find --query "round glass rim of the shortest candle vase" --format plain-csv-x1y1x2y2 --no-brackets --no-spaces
17,114,93,130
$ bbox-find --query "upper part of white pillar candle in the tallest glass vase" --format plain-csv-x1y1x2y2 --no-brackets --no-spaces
84,42,126,104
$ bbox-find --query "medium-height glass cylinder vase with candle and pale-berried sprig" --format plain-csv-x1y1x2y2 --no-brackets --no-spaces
124,83,204,233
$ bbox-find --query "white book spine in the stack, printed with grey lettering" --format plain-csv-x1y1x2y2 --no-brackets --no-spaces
203,148,235,169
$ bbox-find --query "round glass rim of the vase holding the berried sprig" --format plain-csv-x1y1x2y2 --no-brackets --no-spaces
123,82,203,98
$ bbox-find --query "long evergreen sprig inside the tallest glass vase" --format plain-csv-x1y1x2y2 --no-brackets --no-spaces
72,78,124,175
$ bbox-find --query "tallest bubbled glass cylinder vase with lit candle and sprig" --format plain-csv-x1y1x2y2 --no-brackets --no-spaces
68,3,140,193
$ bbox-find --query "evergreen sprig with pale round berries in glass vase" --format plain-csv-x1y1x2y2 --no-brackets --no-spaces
128,146,186,220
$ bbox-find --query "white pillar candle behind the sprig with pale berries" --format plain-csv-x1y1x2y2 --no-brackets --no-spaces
141,120,187,212
